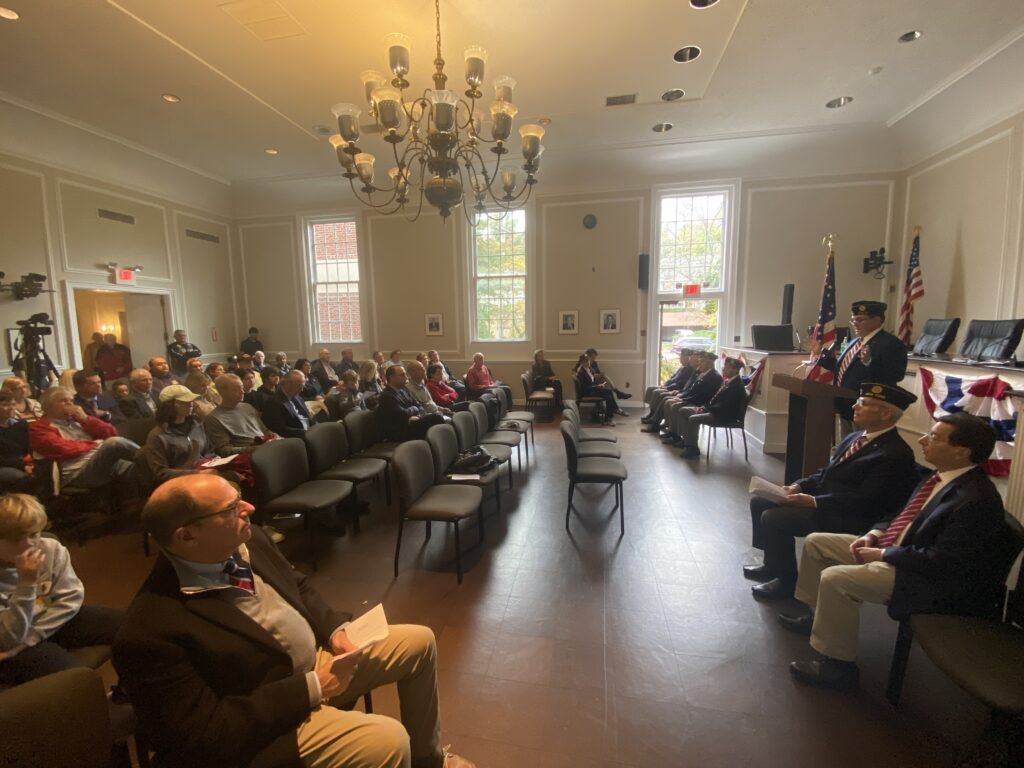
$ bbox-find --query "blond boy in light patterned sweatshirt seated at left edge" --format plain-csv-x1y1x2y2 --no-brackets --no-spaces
0,494,124,688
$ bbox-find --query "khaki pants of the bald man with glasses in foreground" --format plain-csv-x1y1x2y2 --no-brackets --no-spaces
298,625,441,768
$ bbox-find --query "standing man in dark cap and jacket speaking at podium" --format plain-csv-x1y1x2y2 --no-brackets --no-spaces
810,301,906,437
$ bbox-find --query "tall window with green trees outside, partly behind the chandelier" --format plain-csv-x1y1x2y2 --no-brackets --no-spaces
473,210,526,341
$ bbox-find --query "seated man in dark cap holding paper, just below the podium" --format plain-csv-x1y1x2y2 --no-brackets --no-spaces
743,382,920,600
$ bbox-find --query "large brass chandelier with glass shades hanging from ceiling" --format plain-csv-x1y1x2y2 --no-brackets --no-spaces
330,0,544,226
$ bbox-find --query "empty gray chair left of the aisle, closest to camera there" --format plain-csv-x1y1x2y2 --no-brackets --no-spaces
393,440,483,584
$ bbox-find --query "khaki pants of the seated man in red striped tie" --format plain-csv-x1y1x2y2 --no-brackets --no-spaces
797,534,896,662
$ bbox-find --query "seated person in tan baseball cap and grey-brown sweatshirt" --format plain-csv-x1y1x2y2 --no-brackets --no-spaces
135,384,216,487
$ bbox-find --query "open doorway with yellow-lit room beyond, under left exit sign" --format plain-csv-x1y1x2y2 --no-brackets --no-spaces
74,288,173,376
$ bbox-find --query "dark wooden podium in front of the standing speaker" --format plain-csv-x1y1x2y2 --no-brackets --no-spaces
771,374,859,485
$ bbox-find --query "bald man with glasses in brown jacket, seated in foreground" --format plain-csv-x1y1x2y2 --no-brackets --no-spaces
114,474,472,768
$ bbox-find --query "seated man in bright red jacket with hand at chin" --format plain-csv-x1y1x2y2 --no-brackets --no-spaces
29,387,138,487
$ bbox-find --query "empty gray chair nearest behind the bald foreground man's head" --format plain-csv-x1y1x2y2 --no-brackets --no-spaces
252,437,354,569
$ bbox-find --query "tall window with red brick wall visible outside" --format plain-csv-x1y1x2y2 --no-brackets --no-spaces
308,219,362,343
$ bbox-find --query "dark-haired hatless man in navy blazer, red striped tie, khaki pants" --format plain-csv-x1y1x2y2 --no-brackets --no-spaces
779,413,1019,690
